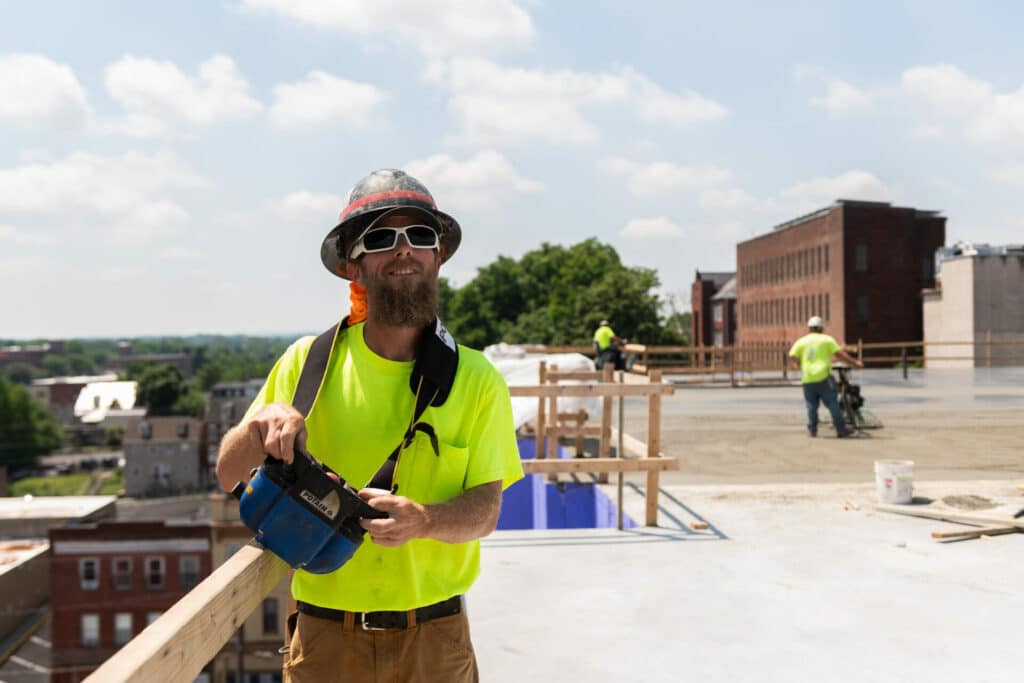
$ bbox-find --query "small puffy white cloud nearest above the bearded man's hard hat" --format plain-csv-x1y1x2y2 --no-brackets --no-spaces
270,71,386,129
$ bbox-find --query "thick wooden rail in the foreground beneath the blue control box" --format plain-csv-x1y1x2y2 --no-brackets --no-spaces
85,545,290,683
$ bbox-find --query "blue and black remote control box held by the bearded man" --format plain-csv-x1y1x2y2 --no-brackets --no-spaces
231,446,387,573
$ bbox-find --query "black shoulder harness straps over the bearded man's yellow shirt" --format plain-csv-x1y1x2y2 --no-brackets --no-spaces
292,317,459,493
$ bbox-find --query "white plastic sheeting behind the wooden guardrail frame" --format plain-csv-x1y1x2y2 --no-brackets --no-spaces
483,344,601,429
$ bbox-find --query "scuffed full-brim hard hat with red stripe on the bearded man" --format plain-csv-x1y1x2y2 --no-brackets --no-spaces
321,168,462,278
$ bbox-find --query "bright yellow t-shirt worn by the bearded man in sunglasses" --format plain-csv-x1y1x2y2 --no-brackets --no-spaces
246,324,522,611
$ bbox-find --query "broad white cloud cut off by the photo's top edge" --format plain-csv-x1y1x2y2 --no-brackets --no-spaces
243,0,535,57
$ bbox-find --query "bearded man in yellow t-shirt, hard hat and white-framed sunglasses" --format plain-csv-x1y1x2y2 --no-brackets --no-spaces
217,169,522,683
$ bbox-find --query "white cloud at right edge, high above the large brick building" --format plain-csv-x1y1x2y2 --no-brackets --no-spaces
900,65,1024,143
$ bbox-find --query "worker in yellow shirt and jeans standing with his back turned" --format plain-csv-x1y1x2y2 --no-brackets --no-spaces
790,315,863,438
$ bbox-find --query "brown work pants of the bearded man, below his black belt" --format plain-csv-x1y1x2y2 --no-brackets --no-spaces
283,610,480,683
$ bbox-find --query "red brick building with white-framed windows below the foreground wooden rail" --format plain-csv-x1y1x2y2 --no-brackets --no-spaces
49,521,211,683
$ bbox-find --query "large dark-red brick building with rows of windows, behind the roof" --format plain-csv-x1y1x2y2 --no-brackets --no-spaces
736,200,946,346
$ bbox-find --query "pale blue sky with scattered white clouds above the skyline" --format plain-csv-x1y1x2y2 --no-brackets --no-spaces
0,0,1024,339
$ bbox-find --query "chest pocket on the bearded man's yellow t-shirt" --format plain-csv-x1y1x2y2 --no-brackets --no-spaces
396,431,469,505
